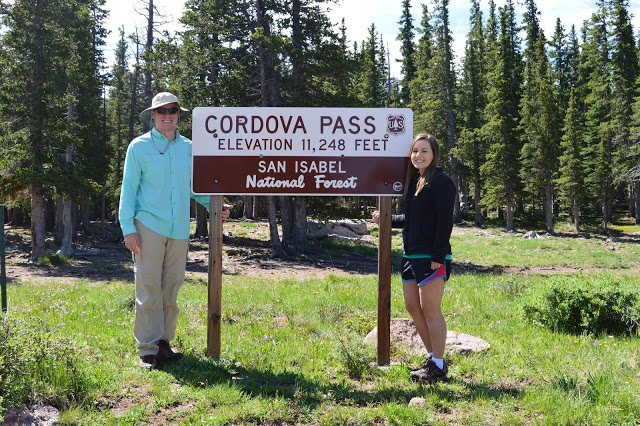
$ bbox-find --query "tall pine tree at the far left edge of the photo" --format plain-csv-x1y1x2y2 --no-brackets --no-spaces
0,0,75,261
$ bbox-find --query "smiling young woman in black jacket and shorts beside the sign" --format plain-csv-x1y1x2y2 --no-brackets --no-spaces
373,134,456,381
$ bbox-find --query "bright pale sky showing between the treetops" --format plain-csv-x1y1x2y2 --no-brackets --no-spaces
105,0,640,78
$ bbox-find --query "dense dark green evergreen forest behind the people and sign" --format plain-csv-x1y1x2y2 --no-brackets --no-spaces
0,0,640,260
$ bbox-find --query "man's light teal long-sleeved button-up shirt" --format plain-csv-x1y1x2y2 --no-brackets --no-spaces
119,127,209,239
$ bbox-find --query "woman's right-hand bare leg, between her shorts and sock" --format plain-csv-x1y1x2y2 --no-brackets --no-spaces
420,278,447,358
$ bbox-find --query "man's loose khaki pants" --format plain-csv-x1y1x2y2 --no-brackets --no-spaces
133,220,189,356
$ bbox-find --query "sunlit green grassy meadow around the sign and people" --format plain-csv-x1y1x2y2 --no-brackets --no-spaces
0,218,640,425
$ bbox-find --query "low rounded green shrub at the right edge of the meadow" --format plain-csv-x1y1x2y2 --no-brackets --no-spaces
524,277,639,334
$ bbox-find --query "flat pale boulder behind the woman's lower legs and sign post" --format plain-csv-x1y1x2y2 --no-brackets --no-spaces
364,318,491,355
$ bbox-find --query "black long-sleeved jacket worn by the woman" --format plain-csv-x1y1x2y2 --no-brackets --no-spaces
391,167,456,263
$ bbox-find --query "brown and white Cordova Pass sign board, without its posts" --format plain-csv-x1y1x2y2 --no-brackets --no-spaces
192,108,413,195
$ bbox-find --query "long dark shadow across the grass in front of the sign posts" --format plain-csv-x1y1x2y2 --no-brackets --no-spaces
162,356,522,409
